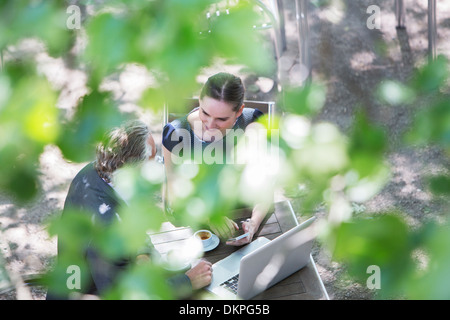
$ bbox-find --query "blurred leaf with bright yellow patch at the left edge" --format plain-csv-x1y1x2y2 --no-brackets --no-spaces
0,63,60,201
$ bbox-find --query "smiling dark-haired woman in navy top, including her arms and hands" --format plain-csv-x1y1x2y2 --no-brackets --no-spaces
162,72,266,245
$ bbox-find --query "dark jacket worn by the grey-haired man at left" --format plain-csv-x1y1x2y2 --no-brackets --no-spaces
47,162,191,299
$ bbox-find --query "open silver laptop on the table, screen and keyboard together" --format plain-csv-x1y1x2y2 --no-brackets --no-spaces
205,217,315,300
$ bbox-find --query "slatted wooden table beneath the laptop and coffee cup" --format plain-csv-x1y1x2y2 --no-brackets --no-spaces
150,201,329,300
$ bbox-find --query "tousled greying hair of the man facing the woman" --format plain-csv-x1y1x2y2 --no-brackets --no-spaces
94,121,152,182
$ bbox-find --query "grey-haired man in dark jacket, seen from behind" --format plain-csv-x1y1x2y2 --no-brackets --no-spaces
47,121,211,299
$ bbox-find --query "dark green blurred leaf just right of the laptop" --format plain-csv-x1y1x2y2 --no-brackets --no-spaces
334,214,412,295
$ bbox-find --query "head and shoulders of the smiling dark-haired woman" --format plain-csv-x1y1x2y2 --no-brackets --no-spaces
162,72,263,156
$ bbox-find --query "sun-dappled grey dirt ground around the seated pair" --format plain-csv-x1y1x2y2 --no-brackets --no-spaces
0,0,450,300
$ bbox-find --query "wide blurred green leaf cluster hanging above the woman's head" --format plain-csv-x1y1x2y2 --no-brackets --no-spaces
83,0,274,106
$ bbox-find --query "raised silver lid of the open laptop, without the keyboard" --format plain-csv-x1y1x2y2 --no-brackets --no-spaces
238,217,315,299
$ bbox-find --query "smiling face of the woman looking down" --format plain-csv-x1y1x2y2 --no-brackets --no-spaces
199,96,244,136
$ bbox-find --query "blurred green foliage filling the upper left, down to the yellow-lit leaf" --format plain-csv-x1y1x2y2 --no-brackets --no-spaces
0,0,274,201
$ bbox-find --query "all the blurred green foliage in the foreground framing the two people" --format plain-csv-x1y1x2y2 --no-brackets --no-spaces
0,0,450,299
